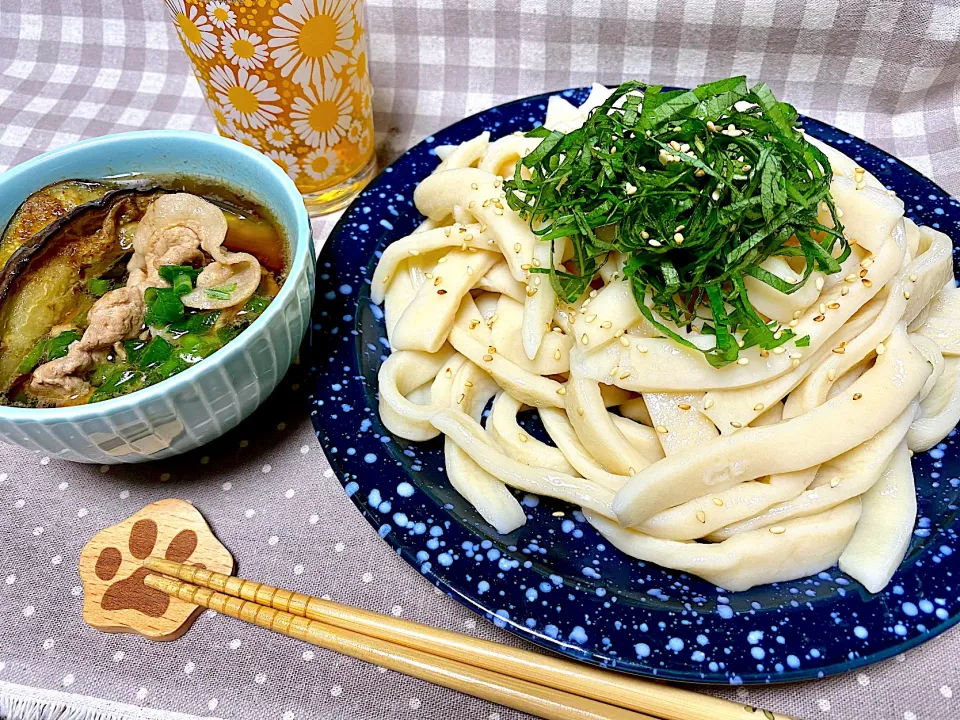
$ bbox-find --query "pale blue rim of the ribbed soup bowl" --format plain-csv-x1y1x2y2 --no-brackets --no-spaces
0,130,316,424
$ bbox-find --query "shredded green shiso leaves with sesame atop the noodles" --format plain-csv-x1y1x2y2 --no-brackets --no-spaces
504,77,850,367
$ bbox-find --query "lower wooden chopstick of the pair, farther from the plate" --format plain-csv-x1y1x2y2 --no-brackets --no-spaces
144,575,656,720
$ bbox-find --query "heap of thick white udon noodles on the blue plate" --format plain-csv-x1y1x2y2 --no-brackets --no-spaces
371,87,960,592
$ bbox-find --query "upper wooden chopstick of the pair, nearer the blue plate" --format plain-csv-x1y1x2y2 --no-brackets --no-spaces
144,558,790,720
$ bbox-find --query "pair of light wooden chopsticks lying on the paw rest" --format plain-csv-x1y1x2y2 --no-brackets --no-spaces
144,558,790,720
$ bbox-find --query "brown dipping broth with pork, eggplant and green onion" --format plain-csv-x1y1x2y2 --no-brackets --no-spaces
0,177,288,408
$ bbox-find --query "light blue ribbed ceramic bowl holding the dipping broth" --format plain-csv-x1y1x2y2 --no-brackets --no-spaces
0,130,316,464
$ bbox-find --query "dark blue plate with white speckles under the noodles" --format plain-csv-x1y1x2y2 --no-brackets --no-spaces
307,89,960,684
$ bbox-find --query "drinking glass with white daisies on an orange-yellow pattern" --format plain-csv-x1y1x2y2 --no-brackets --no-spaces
164,0,376,215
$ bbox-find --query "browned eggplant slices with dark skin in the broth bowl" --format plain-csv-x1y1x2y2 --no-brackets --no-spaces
0,187,165,395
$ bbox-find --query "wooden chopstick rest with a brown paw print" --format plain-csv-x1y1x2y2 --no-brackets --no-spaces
79,498,233,640
